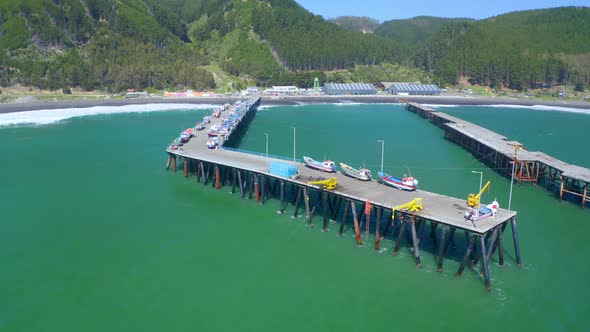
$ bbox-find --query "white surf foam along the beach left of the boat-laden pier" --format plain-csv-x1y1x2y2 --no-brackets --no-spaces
0,104,218,126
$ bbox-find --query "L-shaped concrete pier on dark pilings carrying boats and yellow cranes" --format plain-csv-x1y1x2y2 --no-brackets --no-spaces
167,98,521,290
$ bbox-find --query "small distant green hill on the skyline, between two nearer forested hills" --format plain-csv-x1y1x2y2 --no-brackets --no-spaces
374,16,473,49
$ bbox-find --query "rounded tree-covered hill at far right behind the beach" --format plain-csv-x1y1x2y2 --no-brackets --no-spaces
416,7,590,90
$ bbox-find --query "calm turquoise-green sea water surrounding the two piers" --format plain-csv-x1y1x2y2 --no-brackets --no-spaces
0,105,590,331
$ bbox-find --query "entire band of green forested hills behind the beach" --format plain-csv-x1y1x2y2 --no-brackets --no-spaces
0,0,590,91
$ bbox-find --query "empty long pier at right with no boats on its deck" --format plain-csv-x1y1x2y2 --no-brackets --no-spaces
406,103,590,207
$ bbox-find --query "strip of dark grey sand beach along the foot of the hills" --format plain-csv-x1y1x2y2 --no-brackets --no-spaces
0,95,590,113
